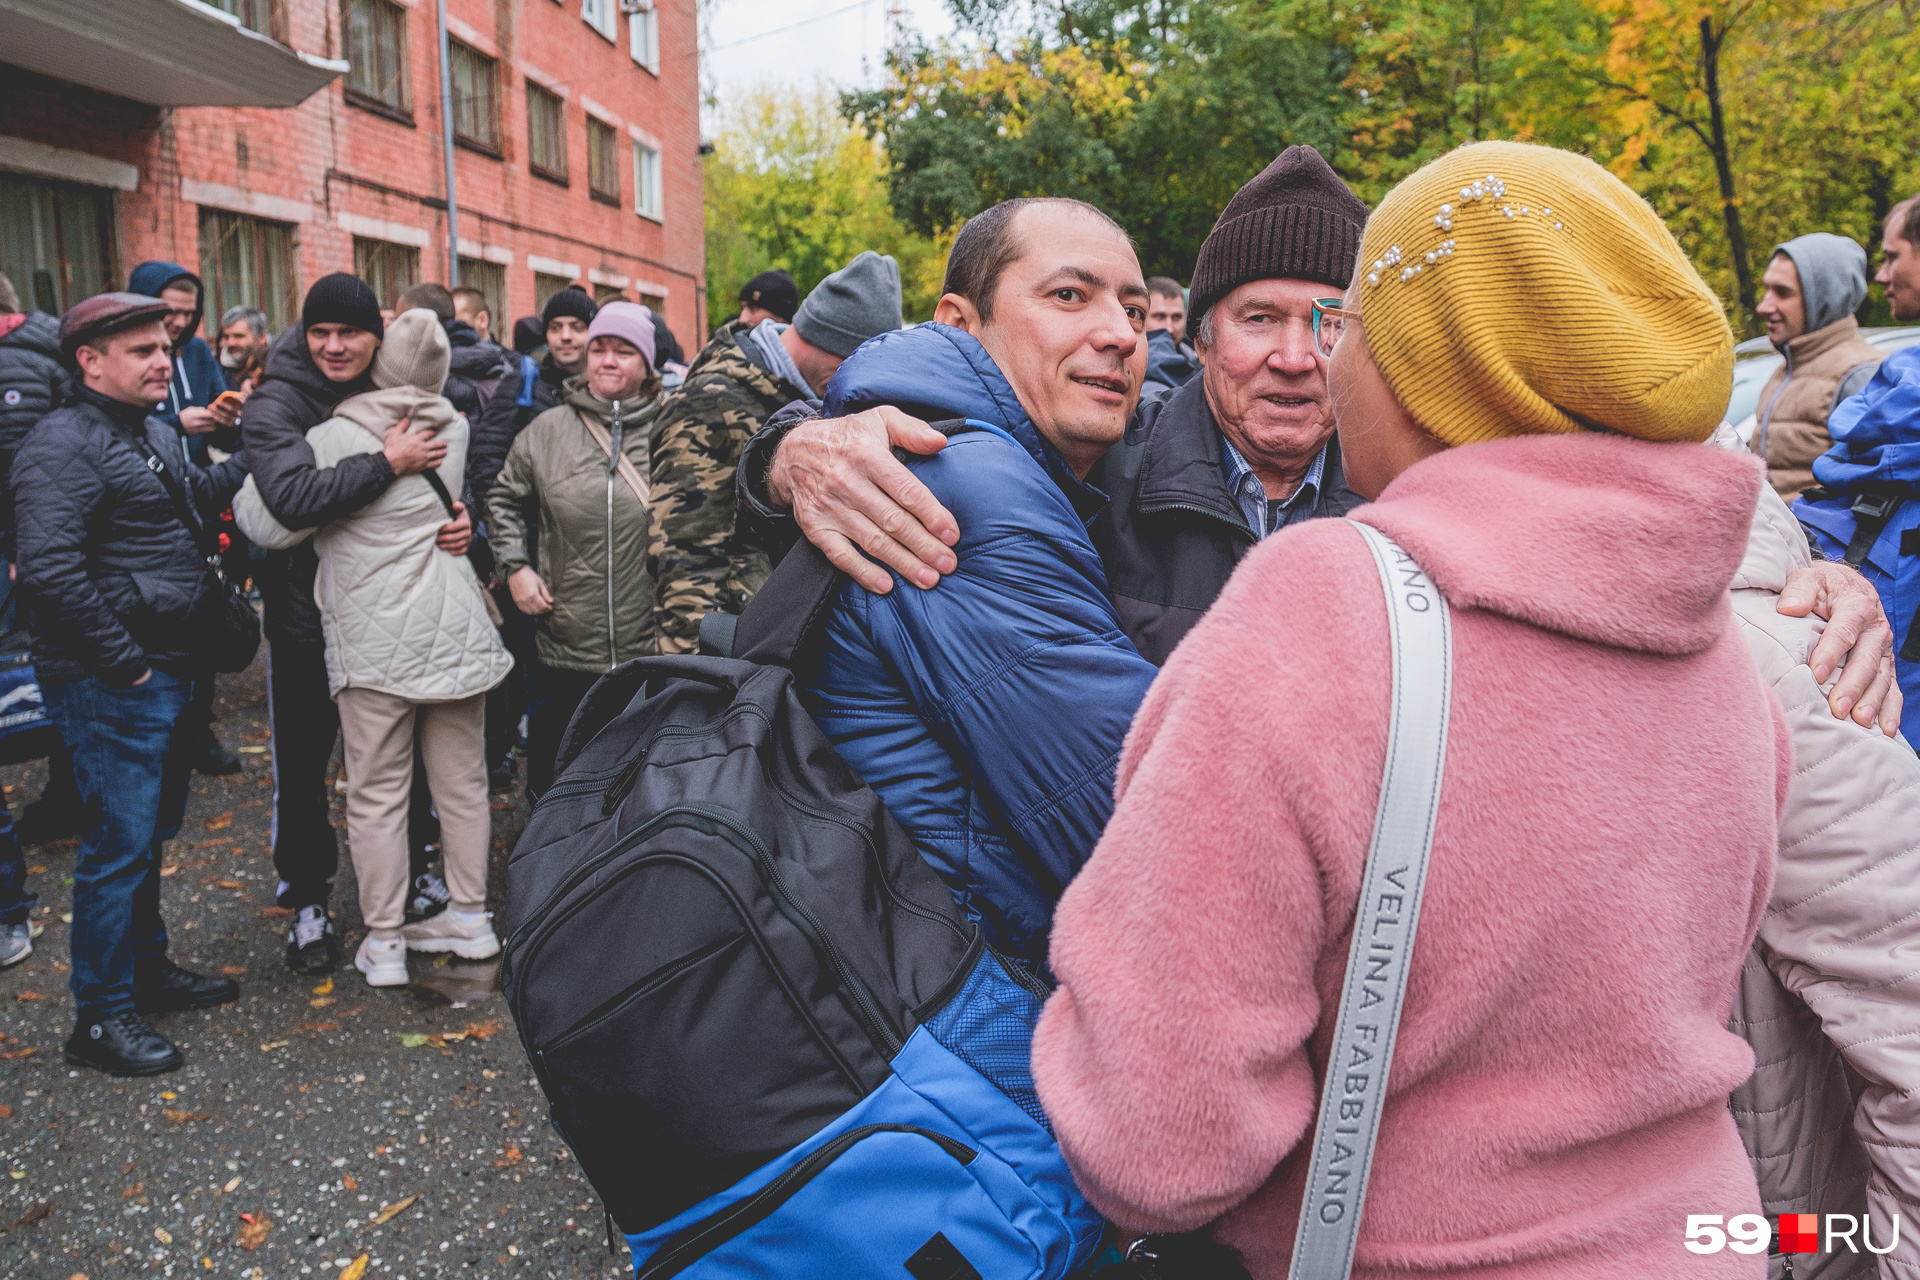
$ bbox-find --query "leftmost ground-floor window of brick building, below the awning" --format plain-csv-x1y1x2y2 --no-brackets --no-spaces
0,173,117,315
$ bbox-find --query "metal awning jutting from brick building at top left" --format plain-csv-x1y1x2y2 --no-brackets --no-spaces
0,0,348,107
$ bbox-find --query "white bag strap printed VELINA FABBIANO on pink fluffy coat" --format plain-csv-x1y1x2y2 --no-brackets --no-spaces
1286,522,1453,1280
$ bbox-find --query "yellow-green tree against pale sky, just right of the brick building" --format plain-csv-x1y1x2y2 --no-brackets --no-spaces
705,88,945,324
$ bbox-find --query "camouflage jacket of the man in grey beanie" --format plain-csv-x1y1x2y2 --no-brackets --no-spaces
653,324,812,652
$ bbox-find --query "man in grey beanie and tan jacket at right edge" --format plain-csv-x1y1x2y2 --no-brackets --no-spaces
1749,230,1884,503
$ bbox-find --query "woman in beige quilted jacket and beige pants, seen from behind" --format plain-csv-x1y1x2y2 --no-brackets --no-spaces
234,307,513,986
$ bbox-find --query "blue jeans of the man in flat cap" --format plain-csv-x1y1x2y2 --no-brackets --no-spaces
40,670,194,1017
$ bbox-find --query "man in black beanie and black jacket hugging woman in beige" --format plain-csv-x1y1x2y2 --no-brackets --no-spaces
240,271,472,973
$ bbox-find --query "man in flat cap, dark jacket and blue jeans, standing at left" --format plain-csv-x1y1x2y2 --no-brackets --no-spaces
10,294,246,1075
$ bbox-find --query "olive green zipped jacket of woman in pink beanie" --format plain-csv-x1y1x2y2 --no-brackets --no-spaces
486,378,659,672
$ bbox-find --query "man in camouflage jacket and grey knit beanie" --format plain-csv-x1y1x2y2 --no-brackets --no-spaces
653,249,900,652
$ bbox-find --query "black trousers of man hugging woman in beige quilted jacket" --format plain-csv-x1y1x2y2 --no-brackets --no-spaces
267,639,435,912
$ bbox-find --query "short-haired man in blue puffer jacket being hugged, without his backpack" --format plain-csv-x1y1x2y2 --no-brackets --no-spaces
801,200,1156,965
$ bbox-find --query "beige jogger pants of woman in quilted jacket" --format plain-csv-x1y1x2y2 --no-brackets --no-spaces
336,687,492,935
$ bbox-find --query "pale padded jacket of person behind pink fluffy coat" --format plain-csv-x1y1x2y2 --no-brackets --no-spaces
1732,433,1920,1280
